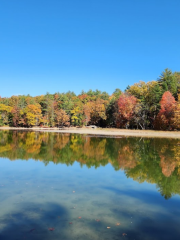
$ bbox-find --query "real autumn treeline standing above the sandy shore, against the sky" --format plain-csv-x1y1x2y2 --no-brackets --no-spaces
0,69,180,130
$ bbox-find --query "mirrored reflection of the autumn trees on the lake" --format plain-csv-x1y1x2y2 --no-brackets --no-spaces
0,131,180,199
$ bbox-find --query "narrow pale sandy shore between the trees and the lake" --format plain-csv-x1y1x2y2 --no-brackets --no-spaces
0,127,180,138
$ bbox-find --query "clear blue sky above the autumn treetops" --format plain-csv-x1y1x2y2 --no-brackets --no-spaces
0,0,180,97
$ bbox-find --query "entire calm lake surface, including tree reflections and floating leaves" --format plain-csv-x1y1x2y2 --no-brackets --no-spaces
0,131,180,240
